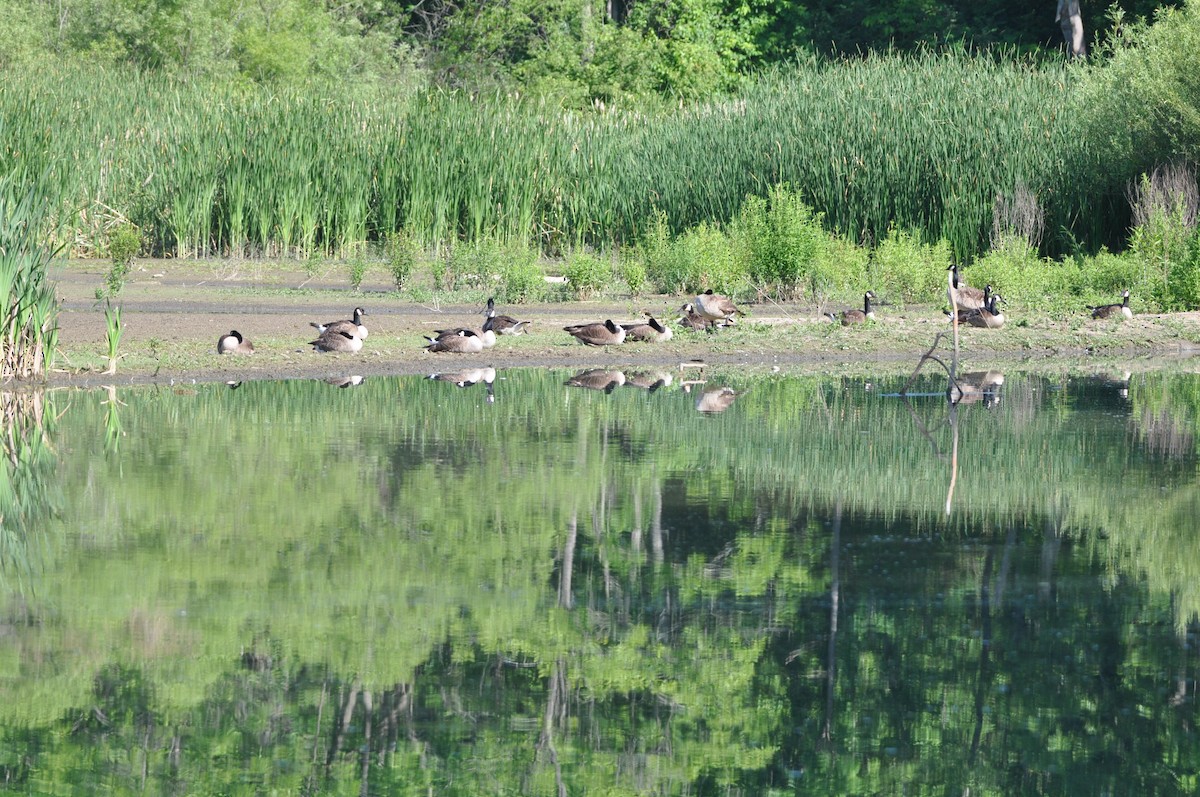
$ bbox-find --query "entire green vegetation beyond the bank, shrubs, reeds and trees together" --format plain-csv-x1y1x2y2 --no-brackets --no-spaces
0,0,1200,374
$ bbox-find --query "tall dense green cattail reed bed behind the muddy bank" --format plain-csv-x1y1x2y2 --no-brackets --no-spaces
0,54,1111,257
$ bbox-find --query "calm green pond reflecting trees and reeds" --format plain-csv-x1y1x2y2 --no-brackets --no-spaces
0,367,1200,795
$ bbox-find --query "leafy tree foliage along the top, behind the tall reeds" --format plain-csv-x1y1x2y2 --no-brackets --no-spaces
0,0,1175,101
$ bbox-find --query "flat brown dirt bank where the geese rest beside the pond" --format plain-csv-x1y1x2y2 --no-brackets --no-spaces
42,260,1200,385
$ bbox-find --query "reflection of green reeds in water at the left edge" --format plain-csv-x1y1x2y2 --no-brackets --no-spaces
0,392,60,586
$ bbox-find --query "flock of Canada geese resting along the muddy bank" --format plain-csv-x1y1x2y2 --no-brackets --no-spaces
217,264,1133,354
